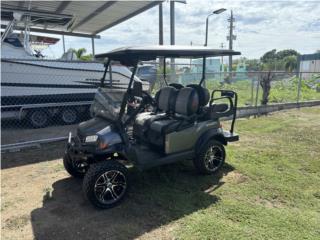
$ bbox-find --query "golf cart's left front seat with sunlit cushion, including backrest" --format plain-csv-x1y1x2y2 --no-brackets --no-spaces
133,86,178,139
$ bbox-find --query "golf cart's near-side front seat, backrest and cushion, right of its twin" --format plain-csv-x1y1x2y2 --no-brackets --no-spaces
146,87,199,150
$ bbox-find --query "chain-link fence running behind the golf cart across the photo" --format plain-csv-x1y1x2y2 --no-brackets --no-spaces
1,59,320,146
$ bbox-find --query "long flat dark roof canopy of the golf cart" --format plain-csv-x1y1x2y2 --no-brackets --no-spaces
95,45,241,62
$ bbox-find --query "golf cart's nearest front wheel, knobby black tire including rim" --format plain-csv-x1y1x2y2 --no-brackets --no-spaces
83,160,129,209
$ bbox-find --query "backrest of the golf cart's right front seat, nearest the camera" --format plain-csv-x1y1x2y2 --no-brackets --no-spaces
174,87,199,116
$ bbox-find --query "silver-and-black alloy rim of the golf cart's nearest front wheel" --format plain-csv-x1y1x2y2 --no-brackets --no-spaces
94,170,127,204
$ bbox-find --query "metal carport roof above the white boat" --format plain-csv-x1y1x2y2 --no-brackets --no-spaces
1,0,162,37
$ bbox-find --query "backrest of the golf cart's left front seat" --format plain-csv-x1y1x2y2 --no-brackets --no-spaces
155,86,178,112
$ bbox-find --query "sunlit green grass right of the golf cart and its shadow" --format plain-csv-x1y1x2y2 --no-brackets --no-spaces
168,108,320,239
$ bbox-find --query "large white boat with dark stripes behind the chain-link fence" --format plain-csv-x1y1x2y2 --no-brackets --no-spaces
1,34,148,126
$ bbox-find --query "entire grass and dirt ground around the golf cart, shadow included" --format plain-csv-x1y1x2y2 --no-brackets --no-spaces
1,107,320,240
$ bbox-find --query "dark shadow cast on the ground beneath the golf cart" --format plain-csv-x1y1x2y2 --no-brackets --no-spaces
31,162,233,240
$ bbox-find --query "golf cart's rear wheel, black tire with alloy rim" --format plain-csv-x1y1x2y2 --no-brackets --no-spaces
193,140,226,174
